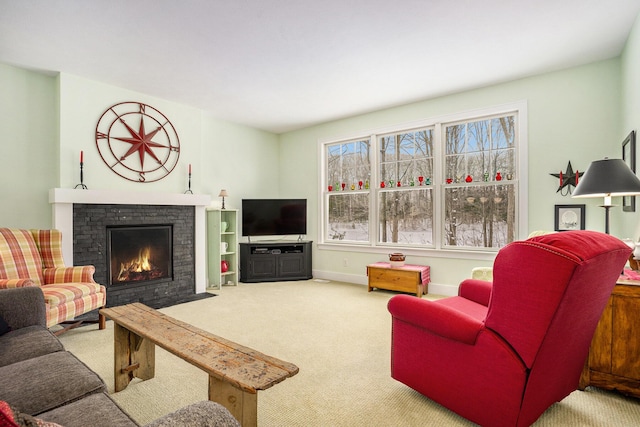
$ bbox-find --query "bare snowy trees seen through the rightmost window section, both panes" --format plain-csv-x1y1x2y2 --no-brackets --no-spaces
443,115,516,248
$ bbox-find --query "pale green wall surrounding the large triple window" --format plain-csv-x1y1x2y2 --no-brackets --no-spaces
280,59,621,293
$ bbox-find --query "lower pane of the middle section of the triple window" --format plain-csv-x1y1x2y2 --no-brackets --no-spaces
378,187,433,246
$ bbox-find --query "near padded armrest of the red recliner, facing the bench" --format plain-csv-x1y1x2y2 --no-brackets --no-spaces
387,295,484,345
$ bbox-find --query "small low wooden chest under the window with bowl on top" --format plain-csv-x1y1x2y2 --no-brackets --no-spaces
367,262,431,298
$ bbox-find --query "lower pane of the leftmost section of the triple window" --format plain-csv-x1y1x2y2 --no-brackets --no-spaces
325,192,369,242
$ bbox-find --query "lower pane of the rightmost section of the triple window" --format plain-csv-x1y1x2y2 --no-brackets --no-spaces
443,184,516,248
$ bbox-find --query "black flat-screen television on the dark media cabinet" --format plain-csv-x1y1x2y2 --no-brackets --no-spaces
242,199,307,237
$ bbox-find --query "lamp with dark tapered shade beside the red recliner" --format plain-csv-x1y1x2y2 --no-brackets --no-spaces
572,157,640,234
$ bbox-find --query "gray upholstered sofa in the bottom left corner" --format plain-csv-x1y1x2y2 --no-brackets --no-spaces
0,287,240,427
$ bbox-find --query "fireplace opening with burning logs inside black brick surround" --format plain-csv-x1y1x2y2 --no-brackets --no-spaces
107,225,173,285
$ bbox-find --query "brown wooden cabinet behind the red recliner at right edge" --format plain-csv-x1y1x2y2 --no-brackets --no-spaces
579,280,640,397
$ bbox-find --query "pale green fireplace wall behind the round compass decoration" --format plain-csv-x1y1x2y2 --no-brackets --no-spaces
0,64,279,228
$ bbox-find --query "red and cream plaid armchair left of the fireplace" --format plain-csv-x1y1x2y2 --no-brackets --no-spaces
0,228,107,332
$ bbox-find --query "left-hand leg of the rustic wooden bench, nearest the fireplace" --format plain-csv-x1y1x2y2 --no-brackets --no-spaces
113,323,156,392
